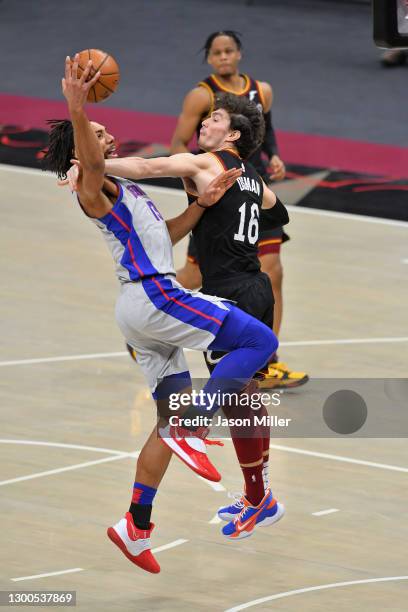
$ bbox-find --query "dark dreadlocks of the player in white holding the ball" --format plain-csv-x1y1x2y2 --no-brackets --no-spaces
41,119,75,179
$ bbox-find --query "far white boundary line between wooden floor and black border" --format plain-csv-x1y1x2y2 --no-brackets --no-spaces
0,164,408,228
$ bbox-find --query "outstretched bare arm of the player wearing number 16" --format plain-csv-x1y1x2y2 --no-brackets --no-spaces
105,153,204,180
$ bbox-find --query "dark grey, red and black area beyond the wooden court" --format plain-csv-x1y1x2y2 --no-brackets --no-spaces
0,0,408,220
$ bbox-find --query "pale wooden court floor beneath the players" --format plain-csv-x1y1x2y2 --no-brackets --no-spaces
0,166,408,612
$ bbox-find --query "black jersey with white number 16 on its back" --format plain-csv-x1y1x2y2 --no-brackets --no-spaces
189,149,263,287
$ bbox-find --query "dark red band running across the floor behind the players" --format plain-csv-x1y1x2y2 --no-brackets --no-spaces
0,94,408,178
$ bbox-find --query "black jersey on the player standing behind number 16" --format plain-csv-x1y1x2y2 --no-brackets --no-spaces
197,74,265,176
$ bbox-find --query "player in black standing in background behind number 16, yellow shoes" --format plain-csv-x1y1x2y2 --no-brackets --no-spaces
171,30,308,388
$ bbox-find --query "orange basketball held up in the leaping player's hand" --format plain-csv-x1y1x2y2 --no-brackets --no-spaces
78,49,120,102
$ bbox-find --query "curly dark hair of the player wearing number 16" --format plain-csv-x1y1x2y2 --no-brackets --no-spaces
215,93,265,159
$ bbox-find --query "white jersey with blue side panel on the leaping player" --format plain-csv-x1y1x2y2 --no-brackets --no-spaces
86,177,176,283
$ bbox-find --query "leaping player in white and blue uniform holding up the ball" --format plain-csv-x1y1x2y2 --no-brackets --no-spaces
48,56,279,573
